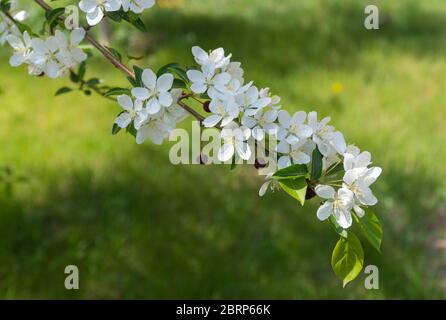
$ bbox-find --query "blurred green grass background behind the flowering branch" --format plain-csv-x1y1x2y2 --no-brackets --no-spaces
0,0,446,299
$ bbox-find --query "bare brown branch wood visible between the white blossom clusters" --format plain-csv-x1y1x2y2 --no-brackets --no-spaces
34,0,204,122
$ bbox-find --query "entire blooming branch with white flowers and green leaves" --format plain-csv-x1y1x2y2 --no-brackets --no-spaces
0,0,382,285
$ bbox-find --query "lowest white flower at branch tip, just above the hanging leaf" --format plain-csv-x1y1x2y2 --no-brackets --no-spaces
315,185,354,229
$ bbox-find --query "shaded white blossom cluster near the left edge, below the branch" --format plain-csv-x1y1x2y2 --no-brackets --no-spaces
7,28,87,79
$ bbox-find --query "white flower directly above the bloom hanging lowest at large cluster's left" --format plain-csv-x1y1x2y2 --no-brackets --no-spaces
203,95,240,128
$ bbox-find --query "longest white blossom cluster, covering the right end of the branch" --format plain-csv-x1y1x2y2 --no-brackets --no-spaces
183,47,381,229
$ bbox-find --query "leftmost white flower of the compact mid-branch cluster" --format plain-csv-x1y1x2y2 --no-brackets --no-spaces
115,94,148,130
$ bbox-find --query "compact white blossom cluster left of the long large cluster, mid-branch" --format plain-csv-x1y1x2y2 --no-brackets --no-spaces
115,69,187,145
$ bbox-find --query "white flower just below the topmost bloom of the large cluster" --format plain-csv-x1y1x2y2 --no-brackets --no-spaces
187,65,231,93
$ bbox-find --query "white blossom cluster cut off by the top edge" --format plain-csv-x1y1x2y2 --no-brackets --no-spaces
79,0,155,26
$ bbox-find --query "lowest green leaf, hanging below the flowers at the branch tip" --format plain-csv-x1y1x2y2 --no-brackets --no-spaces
331,231,364,287
